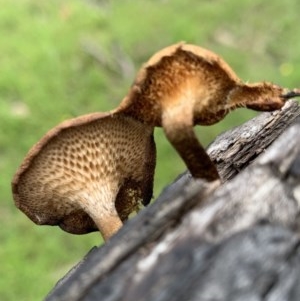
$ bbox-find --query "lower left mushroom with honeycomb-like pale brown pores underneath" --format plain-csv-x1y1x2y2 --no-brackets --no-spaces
12,113,156,240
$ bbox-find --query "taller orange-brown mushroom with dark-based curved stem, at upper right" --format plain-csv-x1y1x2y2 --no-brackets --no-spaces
115,43,300,181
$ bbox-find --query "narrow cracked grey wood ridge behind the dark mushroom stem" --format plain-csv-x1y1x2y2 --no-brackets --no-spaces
208,101,300,179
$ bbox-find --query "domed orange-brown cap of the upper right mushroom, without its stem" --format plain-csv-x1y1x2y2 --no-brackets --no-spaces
115,42,241,126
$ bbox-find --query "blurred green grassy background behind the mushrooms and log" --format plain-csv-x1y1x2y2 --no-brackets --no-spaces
0,0,300,301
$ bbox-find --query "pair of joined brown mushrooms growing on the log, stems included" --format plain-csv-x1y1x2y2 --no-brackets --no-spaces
12,43,300,240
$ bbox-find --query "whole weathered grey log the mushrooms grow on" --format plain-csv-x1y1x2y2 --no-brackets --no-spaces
46,101,300,301
